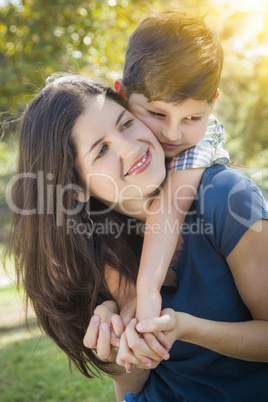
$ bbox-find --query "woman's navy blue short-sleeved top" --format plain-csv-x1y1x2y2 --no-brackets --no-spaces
125,165,268,402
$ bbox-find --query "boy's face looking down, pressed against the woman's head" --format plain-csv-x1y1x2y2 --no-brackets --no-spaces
128,93,212,158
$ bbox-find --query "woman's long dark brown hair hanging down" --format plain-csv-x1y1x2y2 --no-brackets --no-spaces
9,76,137,377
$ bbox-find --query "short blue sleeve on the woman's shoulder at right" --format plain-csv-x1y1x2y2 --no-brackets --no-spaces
203,168,268,258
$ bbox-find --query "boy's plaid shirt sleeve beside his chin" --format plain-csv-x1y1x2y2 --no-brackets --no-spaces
168,114,230,173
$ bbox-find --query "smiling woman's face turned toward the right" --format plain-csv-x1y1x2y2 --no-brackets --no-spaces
73,95,165,212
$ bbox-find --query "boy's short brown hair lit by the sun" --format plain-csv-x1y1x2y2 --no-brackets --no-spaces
123,10,223,103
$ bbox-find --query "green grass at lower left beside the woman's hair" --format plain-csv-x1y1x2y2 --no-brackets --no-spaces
0,287,115,402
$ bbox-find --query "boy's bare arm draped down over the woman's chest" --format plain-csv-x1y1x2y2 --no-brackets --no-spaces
137,169,205,320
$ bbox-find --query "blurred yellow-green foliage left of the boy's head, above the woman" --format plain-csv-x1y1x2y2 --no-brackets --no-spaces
0,0,147,112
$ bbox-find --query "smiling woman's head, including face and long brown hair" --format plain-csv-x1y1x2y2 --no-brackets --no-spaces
10,72,170,377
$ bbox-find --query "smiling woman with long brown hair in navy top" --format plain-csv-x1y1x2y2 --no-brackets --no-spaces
7,77,268,401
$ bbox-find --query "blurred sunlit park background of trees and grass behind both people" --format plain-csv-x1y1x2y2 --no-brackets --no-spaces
0,0,268,402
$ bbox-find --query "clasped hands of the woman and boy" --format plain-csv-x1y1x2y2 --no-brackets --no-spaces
84,300,176,371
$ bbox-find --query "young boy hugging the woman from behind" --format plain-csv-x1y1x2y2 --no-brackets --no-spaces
115,11,229,354
